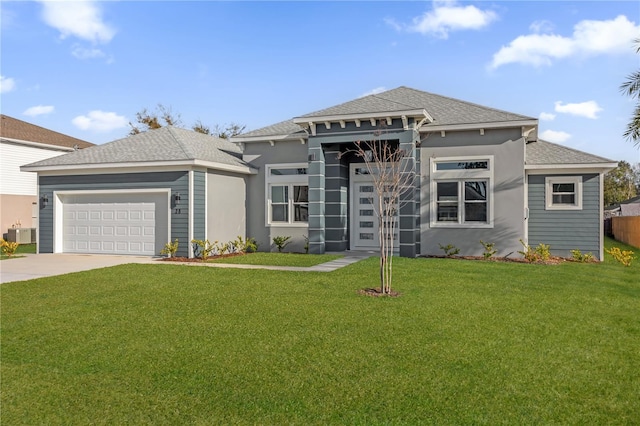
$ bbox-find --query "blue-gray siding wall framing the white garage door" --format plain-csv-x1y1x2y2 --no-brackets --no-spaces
38,171,189,256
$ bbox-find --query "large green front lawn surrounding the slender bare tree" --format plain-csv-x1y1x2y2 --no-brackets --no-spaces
0,238,640,425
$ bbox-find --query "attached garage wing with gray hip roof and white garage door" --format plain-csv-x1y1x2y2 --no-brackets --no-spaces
22,126,257,256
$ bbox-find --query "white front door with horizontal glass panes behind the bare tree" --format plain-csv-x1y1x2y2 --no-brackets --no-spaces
350,164,399,250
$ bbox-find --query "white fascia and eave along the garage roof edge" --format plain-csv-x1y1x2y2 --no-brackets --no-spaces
20,160,258,175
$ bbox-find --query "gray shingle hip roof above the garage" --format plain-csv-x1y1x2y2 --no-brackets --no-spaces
25,126,248,171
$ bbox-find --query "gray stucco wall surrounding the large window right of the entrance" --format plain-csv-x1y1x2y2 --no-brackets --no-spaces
420,128,525,256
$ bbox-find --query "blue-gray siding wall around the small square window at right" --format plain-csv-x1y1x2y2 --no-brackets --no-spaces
528,173,601,258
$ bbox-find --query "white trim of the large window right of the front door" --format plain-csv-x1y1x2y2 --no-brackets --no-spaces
429,155,495,229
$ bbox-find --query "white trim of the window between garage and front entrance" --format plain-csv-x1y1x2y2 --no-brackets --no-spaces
264,163,309,228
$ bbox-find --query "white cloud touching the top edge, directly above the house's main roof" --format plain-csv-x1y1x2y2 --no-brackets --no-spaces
387,0,498,39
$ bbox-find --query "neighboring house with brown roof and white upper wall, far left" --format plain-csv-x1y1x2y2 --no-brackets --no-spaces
0,114,93,234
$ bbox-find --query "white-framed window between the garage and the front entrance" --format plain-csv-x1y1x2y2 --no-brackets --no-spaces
266,164,309,225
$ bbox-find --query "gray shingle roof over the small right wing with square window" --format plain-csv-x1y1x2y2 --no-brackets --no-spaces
525,140,615,165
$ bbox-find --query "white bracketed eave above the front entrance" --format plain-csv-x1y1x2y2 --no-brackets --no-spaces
293,109,433,136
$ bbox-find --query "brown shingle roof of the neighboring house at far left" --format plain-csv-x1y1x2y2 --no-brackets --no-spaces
0,114,93,148
